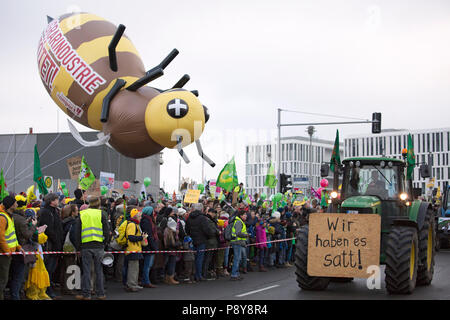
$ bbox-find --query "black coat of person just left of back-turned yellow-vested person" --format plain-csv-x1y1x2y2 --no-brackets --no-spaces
38,205,64,251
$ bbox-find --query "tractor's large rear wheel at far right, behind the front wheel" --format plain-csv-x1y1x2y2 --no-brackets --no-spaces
417,209,436,286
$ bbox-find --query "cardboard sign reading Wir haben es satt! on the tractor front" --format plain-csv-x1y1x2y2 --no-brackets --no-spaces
307,213,381,278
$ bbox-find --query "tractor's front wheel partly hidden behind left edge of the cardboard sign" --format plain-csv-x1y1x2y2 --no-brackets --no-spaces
295,225,330,291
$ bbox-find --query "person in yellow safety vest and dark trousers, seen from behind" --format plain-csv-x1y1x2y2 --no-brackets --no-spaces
73,196,111,300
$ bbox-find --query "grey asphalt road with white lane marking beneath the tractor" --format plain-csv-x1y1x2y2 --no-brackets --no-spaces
65,250,450,301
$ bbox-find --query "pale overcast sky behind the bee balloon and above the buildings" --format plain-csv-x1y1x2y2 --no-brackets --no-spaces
0,0,450,191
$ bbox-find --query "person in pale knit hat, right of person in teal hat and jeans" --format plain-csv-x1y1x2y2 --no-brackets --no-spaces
164,217,182,284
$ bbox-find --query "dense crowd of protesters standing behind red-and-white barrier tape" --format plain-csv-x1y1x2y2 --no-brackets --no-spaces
0,189,321,300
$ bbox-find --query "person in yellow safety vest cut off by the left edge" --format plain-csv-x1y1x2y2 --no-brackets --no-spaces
0,196,23,300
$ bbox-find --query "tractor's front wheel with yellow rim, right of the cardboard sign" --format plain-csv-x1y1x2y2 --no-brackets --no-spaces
385,226,419,294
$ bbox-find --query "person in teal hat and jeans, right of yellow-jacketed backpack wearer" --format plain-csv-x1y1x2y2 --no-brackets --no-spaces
140,206,159,288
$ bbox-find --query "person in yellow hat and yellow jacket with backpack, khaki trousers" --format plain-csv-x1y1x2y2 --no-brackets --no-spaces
125,208,148,292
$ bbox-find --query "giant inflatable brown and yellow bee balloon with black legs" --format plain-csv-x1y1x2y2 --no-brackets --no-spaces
37,13,214,166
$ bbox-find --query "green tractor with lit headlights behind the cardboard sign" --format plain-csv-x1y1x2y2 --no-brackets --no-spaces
295,157,436,294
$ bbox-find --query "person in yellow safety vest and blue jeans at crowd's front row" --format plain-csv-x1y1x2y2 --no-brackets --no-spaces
230,210,248,280
